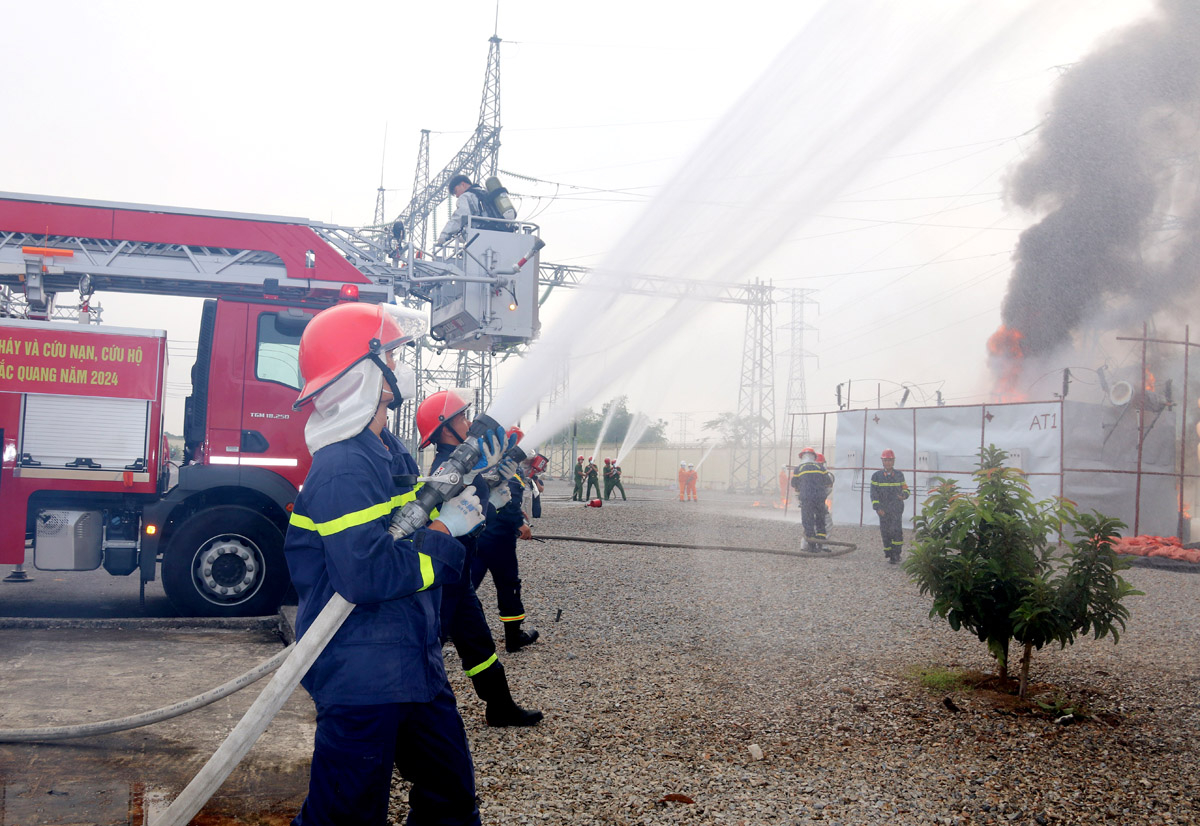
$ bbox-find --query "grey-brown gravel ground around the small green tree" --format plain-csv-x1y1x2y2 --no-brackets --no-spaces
394,485,1200,826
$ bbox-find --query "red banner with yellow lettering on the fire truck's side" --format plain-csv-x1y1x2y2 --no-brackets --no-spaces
0,321,164,401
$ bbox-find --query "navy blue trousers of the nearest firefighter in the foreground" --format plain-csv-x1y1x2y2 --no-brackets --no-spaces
292,683,480,826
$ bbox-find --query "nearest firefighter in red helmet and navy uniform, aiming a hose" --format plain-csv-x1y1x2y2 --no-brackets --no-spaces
283,304,484,826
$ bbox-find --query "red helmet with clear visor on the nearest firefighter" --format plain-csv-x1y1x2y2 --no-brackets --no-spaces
293,304,413,409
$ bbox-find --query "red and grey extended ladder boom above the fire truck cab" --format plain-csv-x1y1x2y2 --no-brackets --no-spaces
0,192,401,317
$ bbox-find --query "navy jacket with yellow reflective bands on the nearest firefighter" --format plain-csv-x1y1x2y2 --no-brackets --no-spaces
283,430,464,705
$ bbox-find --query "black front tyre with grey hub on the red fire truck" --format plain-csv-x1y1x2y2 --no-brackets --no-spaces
162,505,292,617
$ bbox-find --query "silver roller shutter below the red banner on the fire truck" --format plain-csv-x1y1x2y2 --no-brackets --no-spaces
20,393,150,471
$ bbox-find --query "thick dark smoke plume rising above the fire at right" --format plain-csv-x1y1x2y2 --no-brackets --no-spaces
1002,0,1200,357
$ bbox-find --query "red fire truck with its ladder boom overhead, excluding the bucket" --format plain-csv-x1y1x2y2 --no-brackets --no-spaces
0,193,398,616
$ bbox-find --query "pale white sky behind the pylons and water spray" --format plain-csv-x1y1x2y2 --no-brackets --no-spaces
0,0,1151,437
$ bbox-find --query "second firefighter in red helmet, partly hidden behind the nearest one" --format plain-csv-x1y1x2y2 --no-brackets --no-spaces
416,390,542,726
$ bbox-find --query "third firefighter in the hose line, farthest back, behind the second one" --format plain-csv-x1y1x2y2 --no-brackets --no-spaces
470,449,539,653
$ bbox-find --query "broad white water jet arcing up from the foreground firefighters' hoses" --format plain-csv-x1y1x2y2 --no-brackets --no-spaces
488,0,1060,465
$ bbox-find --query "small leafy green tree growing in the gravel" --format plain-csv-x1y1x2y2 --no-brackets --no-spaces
905,445,1141,696
